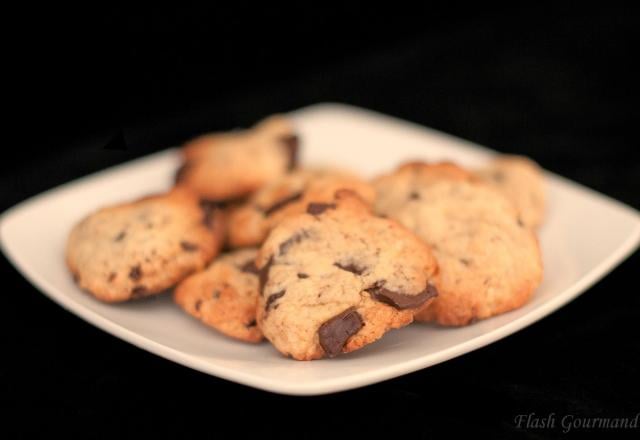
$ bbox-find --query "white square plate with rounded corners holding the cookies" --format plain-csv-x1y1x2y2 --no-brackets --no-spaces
0,104,640,395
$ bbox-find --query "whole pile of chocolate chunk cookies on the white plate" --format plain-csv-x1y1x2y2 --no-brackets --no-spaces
66,116,545,360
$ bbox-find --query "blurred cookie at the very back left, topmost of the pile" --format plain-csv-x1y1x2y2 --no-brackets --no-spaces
176,116,298,201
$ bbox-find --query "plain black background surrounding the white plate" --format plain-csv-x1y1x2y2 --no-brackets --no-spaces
0,3,640,438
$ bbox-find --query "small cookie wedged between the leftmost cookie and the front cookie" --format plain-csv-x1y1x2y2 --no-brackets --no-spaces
173,249,262,342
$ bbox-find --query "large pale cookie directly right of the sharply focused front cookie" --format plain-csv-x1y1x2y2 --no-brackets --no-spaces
375,163,542,326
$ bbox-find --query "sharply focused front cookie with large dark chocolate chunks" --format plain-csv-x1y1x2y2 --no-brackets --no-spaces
256,191,437,360
